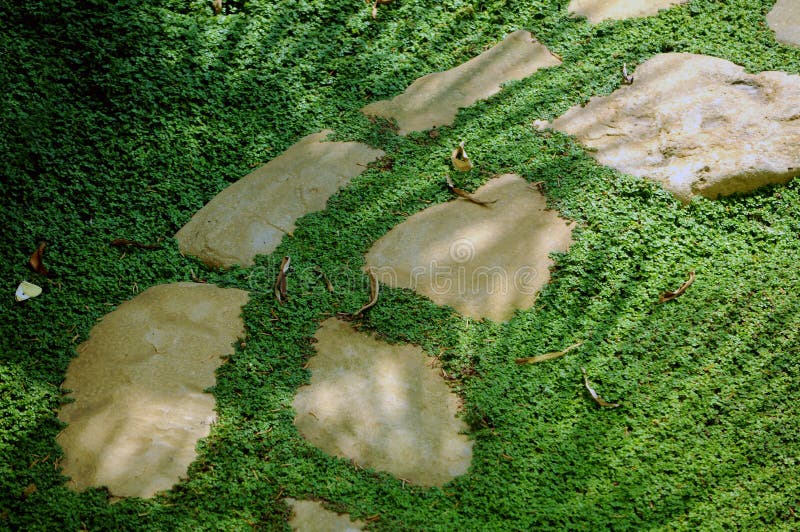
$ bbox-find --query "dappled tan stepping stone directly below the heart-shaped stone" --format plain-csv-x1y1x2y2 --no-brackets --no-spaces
293,318,472,486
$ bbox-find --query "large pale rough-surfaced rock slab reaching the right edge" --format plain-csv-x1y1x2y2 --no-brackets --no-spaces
550,53,800,201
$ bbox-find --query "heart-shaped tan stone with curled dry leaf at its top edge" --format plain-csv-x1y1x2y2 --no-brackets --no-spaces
366,174,572,321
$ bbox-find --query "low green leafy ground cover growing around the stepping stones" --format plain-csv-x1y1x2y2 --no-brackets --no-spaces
0,0,800,530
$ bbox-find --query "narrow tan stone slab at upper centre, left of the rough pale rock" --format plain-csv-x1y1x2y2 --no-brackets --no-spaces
361,31,561,135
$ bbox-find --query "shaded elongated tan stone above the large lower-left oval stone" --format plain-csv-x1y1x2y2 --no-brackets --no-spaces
175,130,384,267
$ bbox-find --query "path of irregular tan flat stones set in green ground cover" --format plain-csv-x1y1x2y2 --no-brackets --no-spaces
58,11,800,530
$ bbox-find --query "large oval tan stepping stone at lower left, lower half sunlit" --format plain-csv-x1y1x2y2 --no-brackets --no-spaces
57,283,248,497
